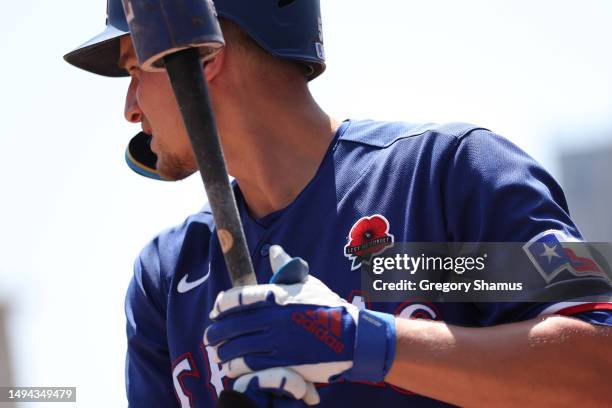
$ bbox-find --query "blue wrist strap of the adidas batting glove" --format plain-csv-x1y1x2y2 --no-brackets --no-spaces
346,310,395,383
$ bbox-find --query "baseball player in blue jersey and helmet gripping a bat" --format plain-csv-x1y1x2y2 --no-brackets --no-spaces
65,0,612,407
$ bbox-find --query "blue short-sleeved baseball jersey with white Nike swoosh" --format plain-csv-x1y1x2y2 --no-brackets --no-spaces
126,121,612,407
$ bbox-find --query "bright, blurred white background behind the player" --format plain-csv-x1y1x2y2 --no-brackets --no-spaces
0,0,612,407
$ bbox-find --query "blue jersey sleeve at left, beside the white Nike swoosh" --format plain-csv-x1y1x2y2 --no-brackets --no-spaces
125,240,176,407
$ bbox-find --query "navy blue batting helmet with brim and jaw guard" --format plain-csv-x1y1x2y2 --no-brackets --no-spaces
64,0,325,179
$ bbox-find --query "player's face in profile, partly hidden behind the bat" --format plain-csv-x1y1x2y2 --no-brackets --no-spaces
119,36,198,180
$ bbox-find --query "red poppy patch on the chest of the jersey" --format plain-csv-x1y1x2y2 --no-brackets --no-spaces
344,214,393,270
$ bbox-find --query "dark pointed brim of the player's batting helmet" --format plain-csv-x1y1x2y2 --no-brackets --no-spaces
64,25,129,77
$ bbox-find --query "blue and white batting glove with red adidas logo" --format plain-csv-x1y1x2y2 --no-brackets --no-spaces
204,245,395,382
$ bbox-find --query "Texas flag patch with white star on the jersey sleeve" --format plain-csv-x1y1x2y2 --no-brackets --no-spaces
523,230,607,283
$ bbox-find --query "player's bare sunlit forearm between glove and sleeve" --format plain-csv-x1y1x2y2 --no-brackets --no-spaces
385,316,612,406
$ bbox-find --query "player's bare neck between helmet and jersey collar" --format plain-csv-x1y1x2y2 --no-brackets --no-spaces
224,88,339,218
